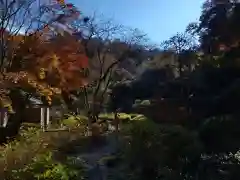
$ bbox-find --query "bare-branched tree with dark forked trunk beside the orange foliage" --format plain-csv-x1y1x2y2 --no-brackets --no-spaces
75,13,151,116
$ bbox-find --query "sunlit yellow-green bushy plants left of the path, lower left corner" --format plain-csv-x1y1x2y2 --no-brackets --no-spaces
0,121,87,180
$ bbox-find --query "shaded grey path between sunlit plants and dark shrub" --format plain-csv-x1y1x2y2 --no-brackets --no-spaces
60,132,119,180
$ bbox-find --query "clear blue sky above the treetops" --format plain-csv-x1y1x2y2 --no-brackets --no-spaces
68,0,204,43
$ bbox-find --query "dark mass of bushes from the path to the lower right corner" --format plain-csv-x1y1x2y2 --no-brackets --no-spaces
116,116,240,180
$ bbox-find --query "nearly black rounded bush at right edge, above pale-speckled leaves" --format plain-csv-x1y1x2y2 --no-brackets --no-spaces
199,115,240,154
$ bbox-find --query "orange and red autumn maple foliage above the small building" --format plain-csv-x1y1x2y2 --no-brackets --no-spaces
0,33,88,107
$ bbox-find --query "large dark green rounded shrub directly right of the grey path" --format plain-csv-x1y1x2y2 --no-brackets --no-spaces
120,118,202,179
